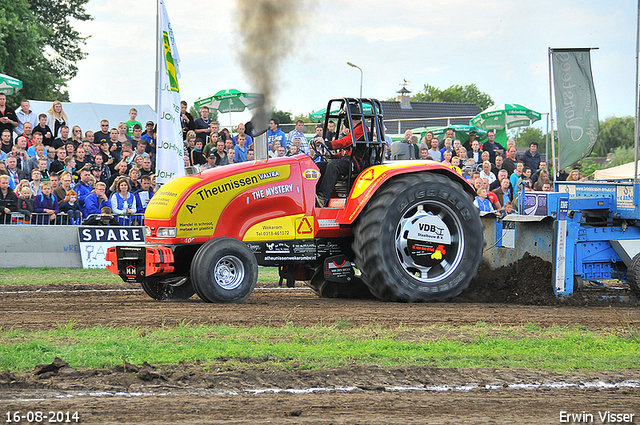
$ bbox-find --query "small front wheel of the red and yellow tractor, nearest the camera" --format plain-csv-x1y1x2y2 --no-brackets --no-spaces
191,238,258,303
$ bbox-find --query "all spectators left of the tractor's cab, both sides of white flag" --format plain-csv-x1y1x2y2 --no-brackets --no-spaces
0,94,344,225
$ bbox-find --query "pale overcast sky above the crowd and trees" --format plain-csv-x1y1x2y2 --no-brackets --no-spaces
69,0,638,124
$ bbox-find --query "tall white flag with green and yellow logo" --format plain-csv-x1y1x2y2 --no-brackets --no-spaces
156,0,184,184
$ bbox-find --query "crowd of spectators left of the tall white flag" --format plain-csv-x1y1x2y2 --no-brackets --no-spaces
0,94,156,225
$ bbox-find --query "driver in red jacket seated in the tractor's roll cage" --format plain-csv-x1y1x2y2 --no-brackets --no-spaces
316,110,364,208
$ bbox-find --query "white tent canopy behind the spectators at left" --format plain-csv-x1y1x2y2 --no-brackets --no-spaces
26,100,156,136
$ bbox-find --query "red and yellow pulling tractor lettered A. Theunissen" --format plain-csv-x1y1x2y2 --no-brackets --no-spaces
107,98,484,303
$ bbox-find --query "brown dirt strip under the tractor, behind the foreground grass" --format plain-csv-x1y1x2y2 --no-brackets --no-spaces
0,284,640,330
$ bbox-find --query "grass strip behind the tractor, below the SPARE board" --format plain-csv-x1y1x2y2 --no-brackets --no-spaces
0,267,279,285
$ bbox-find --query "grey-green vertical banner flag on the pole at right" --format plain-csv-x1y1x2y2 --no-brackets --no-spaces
551,49,600,170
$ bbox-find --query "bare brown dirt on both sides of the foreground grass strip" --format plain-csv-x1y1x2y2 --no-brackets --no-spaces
0,278,640,424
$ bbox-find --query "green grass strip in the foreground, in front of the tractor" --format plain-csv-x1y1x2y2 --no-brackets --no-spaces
0,322,640,371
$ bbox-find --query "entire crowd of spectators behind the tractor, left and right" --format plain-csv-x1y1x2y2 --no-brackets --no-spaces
0,94,582,224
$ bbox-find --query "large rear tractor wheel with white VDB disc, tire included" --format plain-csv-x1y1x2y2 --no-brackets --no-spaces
353,173,484,302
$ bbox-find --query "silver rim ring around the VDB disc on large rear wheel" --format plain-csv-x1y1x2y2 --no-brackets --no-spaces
395,200,465,284
